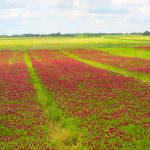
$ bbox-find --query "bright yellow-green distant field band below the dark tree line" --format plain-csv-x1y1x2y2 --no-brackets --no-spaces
0,35,150,51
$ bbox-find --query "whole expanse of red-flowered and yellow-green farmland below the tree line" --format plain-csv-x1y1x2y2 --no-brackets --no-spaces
0,35,150,150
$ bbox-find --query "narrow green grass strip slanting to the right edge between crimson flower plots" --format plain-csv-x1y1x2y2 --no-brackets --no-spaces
62,51,150,83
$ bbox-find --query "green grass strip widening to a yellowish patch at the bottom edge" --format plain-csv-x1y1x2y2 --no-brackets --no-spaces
24,53,85,150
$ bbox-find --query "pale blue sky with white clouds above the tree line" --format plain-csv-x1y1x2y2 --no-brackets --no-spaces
0,0,150,35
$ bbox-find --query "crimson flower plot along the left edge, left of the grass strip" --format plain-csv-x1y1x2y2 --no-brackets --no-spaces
0,51,50,150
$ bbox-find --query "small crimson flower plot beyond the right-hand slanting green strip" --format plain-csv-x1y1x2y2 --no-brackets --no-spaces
72,50,150,74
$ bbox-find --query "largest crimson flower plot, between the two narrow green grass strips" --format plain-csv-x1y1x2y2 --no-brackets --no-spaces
30,50,150,149
